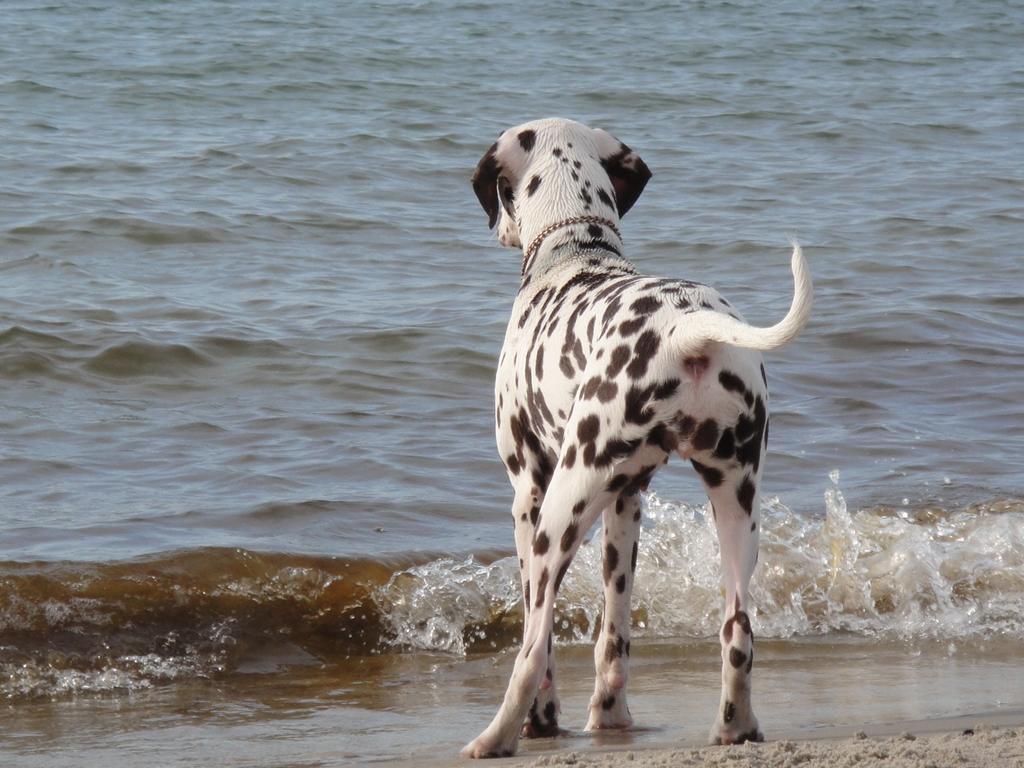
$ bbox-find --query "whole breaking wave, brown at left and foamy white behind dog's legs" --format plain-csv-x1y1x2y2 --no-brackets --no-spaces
0,472,1024,699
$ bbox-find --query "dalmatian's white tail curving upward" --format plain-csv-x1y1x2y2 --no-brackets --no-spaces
679,240,814,353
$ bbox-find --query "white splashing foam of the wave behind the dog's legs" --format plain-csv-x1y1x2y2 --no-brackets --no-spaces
375,471,1024,653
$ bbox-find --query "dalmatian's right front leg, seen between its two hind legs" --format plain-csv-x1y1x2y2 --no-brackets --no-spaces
587,494,640,730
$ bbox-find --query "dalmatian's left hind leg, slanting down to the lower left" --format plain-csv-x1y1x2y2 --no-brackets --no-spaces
463,456,608,758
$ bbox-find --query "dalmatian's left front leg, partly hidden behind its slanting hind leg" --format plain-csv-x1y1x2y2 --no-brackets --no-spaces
512,485,561,738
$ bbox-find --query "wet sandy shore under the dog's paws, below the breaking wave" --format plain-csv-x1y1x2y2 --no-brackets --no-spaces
0,636,1024,768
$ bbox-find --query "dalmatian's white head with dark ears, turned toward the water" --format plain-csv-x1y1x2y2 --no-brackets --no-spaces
473,118,651,247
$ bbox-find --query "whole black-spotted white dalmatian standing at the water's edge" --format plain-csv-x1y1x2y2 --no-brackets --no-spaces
463,119,812,758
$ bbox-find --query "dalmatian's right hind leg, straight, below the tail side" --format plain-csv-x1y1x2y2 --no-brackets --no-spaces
703,469,764,744
